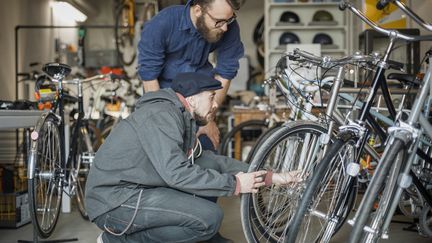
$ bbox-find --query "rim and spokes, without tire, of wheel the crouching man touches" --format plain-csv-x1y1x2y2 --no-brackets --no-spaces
246,125,323,242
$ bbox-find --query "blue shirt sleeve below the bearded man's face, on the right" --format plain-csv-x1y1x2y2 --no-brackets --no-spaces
214,21,244,80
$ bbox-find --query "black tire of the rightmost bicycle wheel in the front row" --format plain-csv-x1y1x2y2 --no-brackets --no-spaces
349,138,404,242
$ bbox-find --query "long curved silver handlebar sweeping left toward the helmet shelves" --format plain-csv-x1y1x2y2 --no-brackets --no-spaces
339,0,432,42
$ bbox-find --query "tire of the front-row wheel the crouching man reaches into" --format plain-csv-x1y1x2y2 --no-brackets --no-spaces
241,121,327,242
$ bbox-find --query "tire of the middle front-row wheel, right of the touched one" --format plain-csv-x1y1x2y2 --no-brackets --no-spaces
287,135,357,242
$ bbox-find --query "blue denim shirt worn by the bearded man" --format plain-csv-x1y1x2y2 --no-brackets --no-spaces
138,3,244,88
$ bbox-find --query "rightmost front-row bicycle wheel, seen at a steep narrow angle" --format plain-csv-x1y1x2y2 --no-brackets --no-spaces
349,139,405,242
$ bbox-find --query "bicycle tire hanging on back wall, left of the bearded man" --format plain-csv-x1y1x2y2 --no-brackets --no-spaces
114,4,136,66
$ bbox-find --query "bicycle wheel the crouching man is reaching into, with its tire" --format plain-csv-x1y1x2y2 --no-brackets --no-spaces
241,121,327,242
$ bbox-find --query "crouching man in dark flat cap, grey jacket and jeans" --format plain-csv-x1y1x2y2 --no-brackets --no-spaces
86,73,300,243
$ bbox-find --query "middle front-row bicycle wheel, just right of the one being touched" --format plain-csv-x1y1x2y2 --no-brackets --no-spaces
287,137,357,242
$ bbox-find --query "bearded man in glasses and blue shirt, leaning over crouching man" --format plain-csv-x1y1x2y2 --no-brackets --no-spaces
138,0,244,150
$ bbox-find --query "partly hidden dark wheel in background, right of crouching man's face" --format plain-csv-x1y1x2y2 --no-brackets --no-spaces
219,120,268,160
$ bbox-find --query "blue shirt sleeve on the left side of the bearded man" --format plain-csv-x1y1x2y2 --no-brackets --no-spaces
138,16,171,81
